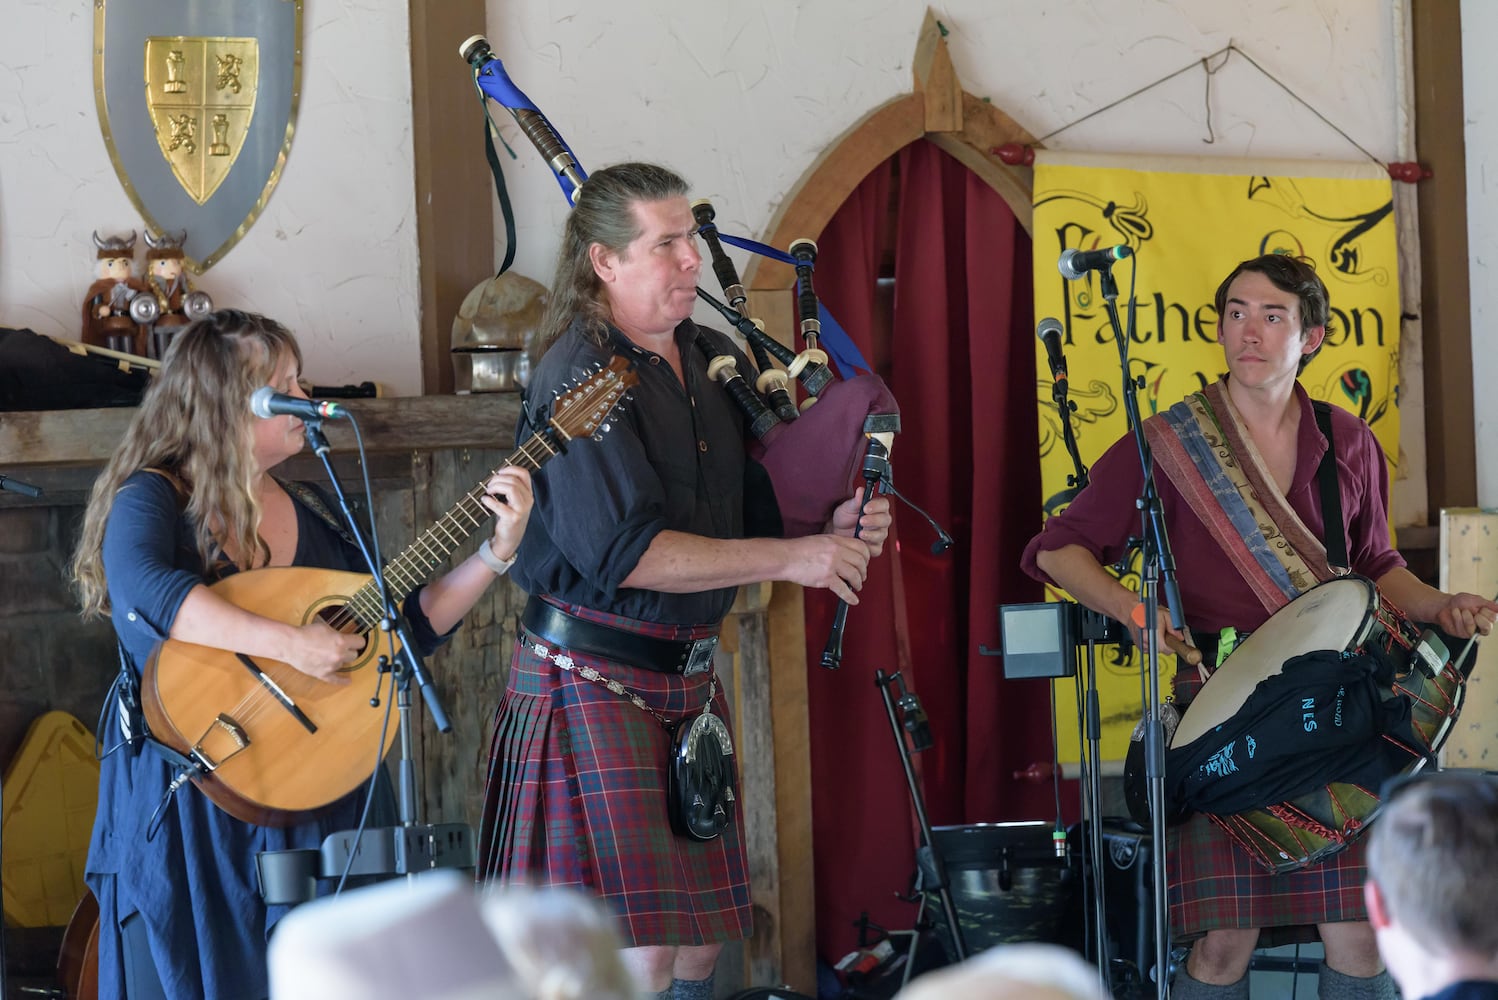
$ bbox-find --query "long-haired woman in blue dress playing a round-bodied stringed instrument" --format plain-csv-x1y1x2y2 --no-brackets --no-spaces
73,310,530,1000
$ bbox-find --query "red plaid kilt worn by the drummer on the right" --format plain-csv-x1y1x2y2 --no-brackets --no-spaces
1165,671,1368,948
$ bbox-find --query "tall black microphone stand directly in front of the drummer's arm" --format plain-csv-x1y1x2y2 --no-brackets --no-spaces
1098,265,1185,1000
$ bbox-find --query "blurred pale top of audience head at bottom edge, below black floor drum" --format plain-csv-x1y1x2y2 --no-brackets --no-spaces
896,945,1107,1000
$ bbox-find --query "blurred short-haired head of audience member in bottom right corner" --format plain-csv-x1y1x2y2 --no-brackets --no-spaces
1363,771,1498,1000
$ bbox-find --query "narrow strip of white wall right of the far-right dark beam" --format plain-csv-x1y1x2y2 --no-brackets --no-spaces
1462,0,1498,509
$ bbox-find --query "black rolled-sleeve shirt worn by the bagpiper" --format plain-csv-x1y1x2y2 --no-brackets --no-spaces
511,320,773,624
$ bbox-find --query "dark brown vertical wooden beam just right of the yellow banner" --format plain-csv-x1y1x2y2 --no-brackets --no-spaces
1410,0,1477,512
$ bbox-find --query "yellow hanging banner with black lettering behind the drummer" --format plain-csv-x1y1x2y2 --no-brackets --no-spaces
1034,153,1399,762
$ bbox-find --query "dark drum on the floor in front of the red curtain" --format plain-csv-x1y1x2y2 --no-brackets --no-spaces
915,820,1074,961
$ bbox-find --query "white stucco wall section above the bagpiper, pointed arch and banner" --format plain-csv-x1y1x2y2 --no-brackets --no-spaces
488,0,1395,288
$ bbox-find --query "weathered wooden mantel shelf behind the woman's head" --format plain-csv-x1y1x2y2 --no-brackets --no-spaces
0,392,520,476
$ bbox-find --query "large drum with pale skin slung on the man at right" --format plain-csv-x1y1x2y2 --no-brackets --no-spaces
1170,576,1467,873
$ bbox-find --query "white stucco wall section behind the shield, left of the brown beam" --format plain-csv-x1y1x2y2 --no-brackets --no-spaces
0,0,421,392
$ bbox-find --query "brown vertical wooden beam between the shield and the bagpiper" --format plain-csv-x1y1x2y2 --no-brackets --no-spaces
410,0,494,394
